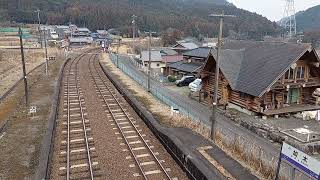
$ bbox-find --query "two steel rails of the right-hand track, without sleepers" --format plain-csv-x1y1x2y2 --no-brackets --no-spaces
89,55,171,180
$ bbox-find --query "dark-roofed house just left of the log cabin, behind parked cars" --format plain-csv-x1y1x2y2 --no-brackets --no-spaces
165,47,211,77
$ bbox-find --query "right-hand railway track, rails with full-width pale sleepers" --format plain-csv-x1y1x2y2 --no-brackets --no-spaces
88,55,177,180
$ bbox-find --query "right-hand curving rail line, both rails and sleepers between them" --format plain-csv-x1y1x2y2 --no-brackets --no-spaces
88,52,171,179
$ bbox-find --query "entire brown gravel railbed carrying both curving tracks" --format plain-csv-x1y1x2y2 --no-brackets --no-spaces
50,50,186,180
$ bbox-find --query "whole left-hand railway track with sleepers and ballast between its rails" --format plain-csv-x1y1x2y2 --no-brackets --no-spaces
59,52,99,180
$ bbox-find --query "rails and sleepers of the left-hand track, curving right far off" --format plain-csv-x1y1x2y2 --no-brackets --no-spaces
60,53,97,180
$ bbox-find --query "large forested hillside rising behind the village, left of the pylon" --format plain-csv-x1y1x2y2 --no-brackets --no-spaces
0,0,279,39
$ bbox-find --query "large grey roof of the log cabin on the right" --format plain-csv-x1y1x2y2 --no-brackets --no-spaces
202,41,319,97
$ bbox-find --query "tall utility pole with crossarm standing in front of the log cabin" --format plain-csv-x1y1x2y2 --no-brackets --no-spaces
209,11,236,141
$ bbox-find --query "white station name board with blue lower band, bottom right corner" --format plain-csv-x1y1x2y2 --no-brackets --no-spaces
281,142,320,180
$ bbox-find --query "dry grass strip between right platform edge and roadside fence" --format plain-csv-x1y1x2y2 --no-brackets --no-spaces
101,54,276,179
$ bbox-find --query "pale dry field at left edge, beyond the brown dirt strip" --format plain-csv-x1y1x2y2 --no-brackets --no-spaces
0,48,58,96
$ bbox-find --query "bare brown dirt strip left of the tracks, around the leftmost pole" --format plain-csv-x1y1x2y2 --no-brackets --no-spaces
0,50,63,180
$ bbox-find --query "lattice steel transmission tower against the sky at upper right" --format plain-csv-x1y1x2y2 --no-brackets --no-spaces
282,0,297,38
